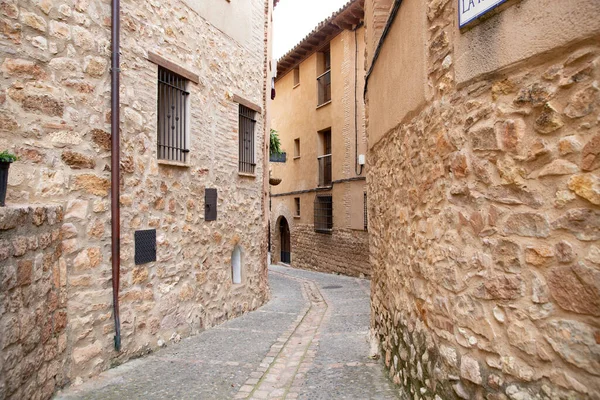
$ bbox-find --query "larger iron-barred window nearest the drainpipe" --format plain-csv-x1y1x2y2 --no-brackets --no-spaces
156,66,190,163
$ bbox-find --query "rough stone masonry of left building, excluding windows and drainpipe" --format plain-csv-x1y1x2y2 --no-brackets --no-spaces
0,0,268,390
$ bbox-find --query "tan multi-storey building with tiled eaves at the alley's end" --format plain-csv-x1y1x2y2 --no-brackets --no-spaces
270,0,370,276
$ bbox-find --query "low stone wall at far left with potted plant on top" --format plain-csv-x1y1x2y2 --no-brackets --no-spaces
0,205,67,399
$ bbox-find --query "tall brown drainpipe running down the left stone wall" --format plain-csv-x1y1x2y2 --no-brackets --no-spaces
110,0,121,351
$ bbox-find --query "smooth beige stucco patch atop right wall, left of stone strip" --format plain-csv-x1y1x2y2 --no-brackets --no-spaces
368,0,430,148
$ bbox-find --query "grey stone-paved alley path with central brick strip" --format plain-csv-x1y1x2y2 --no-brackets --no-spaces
56,266,400,400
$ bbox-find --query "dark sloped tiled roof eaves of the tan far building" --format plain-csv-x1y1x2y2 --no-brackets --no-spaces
275,0,365,80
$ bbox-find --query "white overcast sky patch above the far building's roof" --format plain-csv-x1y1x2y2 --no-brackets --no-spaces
273,0,348,59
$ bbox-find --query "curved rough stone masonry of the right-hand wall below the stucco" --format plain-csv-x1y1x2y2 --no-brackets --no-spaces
368,0,600,400
